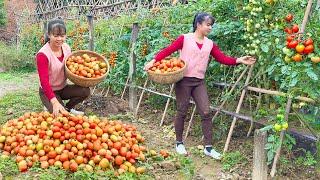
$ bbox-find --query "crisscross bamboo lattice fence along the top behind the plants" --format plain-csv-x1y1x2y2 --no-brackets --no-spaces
34,0,171,20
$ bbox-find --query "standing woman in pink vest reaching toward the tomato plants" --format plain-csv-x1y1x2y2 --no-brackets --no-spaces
145,13,256,159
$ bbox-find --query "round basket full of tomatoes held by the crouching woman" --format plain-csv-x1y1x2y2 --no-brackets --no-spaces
65,50,110,87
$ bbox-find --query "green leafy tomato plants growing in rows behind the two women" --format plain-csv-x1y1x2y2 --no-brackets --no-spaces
21,0,320,98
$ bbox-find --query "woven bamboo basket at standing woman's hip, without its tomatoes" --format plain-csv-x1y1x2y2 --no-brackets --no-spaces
148,58,187,84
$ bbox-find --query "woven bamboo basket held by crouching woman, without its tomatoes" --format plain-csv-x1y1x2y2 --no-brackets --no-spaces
64,50,110,87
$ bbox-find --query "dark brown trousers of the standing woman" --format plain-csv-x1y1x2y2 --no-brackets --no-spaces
174,77,212,145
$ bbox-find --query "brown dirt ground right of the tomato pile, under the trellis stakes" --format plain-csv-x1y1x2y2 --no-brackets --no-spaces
79,90,320,179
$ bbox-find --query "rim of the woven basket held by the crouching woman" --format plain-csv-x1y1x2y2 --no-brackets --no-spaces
64,50,110,80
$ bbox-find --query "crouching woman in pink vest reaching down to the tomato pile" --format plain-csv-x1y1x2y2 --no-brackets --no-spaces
36,19,90,116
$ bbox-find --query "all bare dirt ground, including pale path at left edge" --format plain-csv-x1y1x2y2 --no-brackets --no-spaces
0,73,320,180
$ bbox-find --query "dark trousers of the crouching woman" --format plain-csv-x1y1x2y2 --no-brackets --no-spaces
39,85,90,113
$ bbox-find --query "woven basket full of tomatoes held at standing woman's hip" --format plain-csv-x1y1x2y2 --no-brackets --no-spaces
148,57,187,84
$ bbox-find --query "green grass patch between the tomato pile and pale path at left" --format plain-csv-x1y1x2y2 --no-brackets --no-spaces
0,90,42,124
